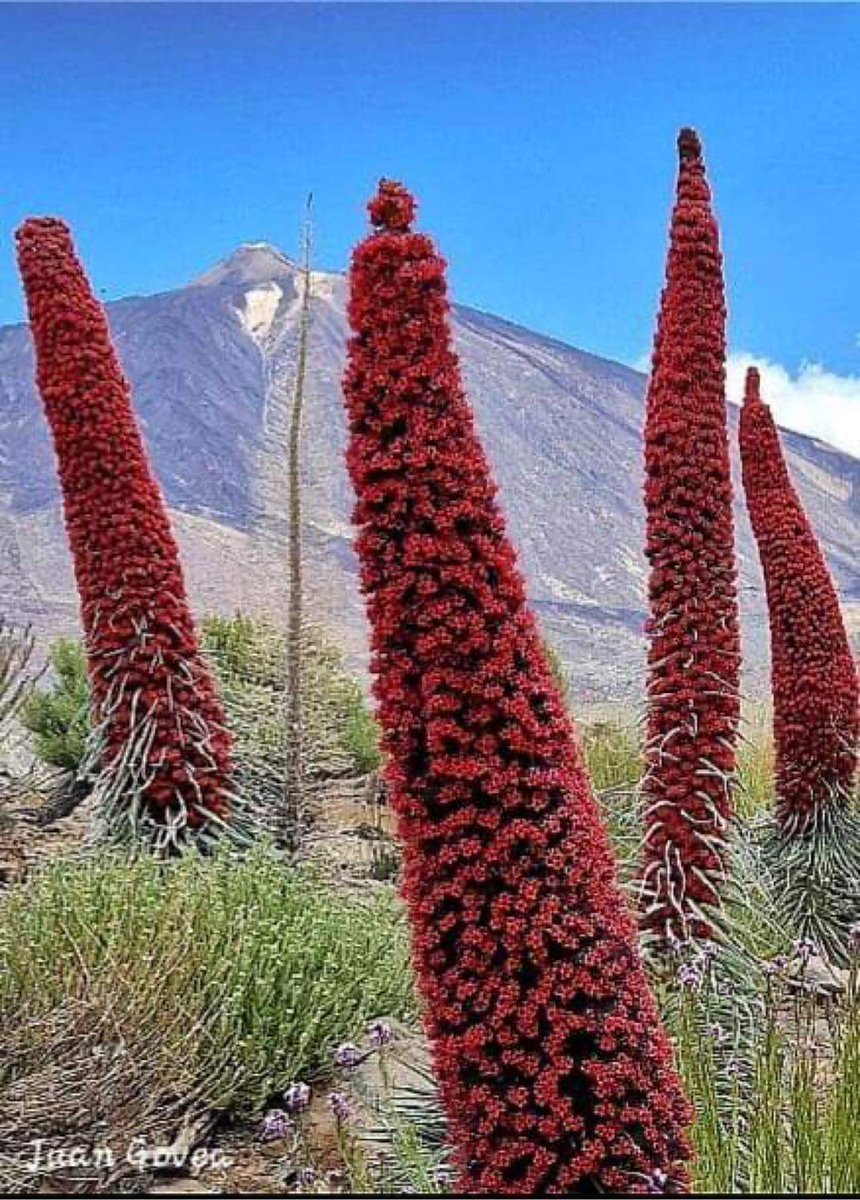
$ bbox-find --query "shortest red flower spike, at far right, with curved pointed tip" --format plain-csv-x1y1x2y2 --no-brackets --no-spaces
740,367,860,834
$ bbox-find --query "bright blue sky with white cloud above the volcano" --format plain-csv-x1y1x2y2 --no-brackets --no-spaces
0,4,860,454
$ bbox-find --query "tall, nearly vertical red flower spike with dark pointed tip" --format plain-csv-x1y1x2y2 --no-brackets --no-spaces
642,130,740,938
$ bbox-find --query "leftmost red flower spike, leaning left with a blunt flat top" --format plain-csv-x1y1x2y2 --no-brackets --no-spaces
17,218,230,829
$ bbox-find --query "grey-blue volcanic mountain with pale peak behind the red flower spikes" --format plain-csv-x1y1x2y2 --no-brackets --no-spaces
0,245,860,703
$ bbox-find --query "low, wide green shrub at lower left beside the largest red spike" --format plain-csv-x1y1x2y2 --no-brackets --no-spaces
0,847,416,1117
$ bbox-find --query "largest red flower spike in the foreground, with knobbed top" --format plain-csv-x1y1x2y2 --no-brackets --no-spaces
344,180,690,1195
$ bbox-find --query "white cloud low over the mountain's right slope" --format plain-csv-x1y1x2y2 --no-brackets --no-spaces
728,354,860,458
